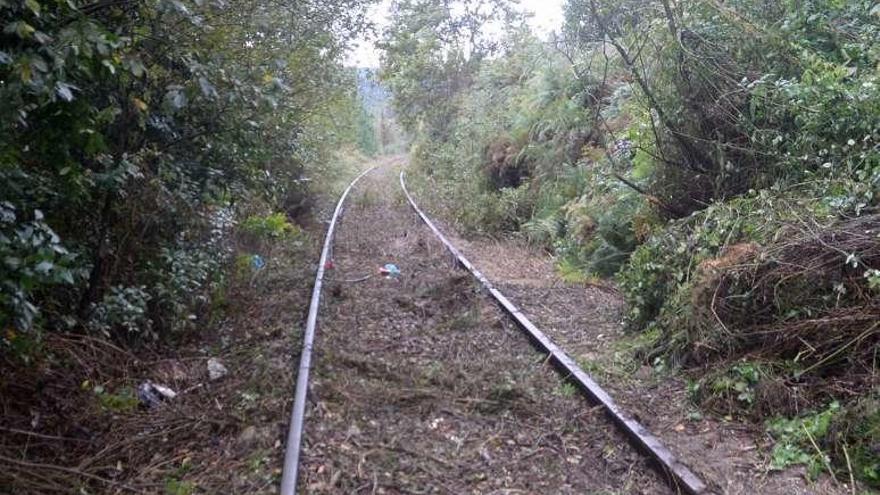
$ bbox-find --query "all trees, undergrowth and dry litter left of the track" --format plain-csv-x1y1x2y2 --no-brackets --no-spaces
0,0,381,494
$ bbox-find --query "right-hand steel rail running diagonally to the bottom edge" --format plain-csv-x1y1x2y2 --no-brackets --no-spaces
400,171,708,495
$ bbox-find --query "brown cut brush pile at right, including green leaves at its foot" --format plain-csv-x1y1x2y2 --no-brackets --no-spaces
682,214,880,486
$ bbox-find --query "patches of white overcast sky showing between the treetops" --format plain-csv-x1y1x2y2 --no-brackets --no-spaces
345,0,565,67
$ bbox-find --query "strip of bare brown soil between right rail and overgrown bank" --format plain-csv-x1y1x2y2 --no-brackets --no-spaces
415,175,853,495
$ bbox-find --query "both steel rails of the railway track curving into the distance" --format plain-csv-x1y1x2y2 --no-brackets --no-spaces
281,169,707,495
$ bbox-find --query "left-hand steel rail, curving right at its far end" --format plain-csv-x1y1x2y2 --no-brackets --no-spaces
281,167,376,495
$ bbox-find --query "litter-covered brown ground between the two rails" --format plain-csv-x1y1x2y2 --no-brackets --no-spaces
300,166,671,494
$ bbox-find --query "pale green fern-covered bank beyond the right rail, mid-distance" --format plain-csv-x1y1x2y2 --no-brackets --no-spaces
388,23,643,276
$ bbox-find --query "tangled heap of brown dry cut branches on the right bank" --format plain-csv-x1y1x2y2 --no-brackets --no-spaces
689,214,880,391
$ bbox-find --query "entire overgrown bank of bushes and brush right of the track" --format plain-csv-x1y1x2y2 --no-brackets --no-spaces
384,0,880,485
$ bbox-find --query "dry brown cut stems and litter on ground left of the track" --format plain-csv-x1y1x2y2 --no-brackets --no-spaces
0,239,313,495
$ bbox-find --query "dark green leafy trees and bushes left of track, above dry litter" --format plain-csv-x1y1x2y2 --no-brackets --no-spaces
0,0,376,354
